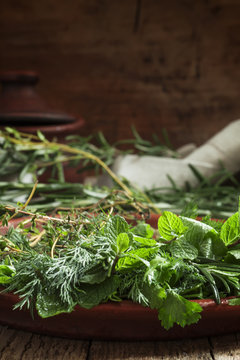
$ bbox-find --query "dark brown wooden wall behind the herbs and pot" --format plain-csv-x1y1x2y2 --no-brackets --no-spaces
0,0,240,145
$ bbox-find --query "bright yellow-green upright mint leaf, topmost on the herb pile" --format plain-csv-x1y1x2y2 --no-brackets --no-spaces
158,211,186,241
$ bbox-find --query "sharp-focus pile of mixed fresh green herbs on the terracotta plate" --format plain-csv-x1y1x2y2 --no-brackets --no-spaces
0,205,240,329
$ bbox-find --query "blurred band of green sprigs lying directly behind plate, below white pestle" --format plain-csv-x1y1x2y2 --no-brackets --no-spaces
0,170,240,219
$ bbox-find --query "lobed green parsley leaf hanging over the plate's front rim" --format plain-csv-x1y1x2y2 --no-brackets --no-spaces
158,290,202,330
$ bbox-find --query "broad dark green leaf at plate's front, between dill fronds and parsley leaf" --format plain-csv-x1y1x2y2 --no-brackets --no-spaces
77,275,120,309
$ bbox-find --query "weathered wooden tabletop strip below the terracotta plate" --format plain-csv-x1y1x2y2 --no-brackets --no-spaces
0,326,240,360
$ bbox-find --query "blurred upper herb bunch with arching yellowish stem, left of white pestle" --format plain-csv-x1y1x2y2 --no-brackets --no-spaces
0,127,178,182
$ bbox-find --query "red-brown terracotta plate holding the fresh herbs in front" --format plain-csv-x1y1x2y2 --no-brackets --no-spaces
0,216,240,340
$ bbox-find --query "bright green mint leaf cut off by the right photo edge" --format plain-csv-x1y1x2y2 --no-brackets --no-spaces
220,212,240,245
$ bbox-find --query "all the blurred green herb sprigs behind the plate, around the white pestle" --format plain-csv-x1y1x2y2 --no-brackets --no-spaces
0,128,240,218
